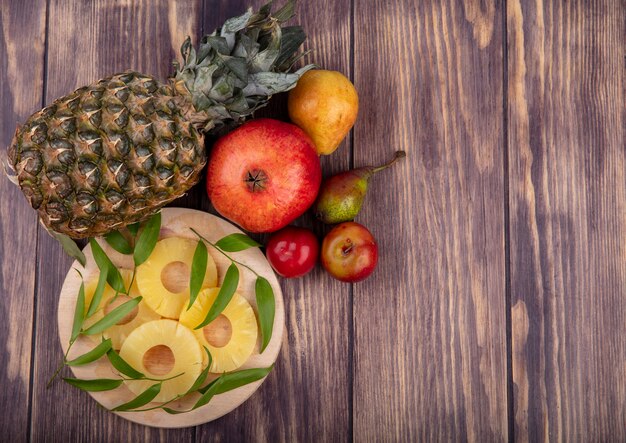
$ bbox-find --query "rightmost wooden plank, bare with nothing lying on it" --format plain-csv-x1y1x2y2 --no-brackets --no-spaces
507,0,626,441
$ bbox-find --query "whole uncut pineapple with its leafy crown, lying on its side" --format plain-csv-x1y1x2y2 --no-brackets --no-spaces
7,2,311,238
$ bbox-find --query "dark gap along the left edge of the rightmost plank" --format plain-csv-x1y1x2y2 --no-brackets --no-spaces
502,0,515,443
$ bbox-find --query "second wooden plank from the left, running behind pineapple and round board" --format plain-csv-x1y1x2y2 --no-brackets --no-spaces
31,0,201,442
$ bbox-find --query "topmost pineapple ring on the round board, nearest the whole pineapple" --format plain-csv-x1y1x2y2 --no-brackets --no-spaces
137,237,217,319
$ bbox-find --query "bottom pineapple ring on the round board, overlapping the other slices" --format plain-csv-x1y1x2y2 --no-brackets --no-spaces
120,319,205,402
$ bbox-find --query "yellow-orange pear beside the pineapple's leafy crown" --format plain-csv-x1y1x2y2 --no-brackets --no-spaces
288,69,359,155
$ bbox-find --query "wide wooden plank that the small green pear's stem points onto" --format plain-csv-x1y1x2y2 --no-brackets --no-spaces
354,0,508,441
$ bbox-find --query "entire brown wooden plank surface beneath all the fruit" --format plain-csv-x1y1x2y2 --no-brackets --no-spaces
0,0,626,442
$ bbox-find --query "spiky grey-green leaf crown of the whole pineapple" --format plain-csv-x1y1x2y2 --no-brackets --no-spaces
173,0,313,131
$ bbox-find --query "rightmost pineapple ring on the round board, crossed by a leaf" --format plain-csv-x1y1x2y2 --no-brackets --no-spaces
180,288,257,373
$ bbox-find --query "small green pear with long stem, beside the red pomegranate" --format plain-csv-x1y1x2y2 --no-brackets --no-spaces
313,151,406,224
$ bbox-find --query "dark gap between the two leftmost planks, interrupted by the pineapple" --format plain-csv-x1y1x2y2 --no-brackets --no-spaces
26,0,50,443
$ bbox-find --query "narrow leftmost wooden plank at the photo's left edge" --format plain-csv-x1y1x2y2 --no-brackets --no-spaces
0,1,46,441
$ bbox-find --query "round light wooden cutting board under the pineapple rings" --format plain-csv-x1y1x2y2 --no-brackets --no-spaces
58,208,285,428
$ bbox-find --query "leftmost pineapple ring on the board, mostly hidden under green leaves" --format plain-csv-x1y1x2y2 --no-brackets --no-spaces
83,269,161,349
